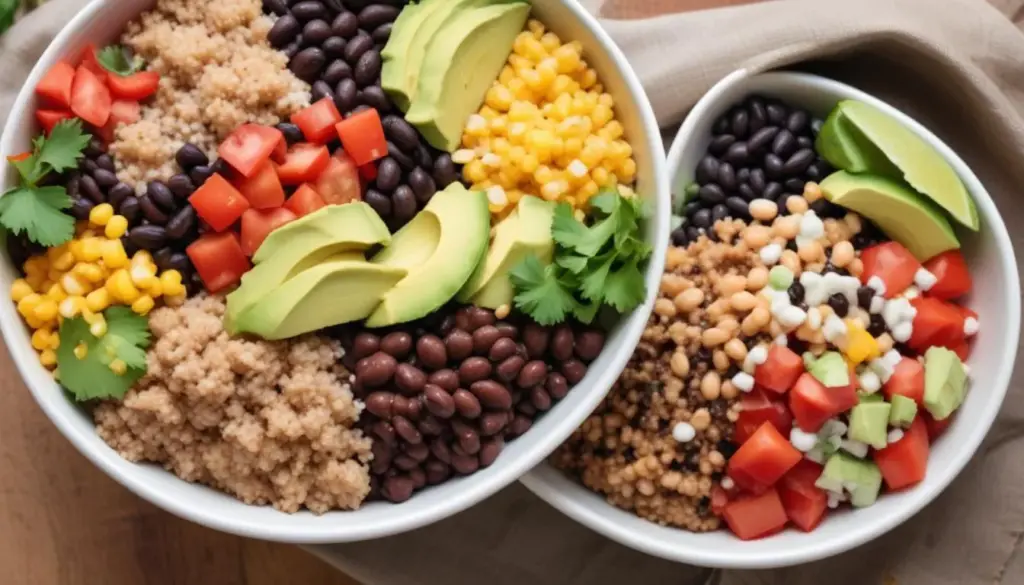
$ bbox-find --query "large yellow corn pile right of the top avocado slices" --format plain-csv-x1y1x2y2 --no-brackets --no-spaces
453,20,637,216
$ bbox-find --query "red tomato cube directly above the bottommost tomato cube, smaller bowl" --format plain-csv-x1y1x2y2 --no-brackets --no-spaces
729,422,803,493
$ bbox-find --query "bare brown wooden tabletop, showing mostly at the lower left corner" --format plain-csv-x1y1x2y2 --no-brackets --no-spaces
0,0,1024,585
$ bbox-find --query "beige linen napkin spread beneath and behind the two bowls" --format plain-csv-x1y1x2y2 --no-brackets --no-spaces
6,0,1024,585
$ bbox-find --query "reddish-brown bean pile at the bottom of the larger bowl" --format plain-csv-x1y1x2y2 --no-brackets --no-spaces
342,307,604,502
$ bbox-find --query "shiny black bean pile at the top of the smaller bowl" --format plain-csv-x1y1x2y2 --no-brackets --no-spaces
672,95,837,246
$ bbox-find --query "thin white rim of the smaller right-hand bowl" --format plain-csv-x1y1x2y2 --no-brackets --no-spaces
520,69,1021,569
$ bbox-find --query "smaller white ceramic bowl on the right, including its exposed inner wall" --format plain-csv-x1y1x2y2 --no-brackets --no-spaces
522,71,1020,569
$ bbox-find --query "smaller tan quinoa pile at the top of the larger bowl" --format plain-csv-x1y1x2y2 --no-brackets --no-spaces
111,0,309,184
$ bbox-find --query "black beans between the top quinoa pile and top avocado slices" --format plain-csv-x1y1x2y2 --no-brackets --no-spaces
263,0,459,231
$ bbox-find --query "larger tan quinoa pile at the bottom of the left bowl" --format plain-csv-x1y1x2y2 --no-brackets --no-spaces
94,295,371,513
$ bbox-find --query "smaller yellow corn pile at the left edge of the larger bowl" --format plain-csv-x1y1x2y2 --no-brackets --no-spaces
10,203,185,368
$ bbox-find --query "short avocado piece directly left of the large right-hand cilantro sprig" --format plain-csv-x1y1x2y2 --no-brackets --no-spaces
456,195,555,308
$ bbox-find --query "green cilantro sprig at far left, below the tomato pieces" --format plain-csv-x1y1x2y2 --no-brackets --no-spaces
0,119,89,247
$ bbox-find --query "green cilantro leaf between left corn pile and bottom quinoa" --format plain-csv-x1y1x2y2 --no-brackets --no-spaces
57,306,150,402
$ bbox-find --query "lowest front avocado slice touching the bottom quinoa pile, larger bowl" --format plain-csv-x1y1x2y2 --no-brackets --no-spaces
233,252,407,340
